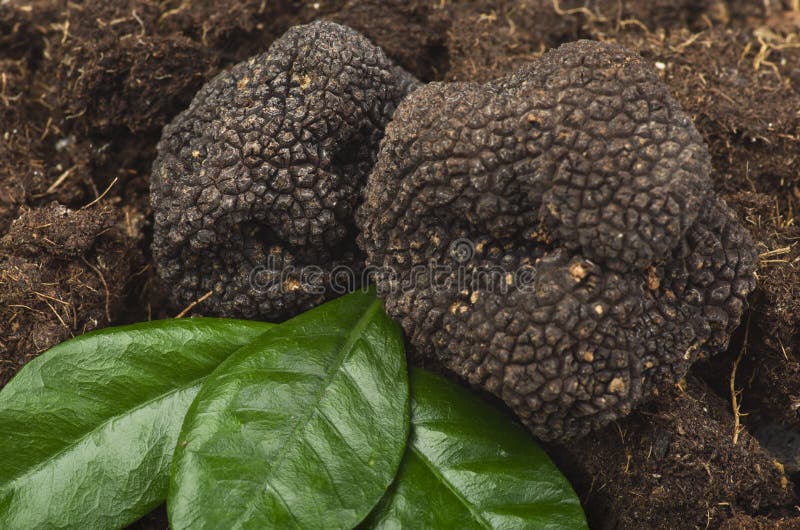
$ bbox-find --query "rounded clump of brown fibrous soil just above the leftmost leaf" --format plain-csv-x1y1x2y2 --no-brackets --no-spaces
0,202,142,386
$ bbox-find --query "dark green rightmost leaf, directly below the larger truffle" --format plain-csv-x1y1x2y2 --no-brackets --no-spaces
363,369,588,529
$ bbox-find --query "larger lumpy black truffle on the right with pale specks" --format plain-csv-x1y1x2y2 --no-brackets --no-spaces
358,41,757,440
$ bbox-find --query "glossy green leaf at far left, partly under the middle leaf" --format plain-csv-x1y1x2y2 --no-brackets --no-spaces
0,318,272,530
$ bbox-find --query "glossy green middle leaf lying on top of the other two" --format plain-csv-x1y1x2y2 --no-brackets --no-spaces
167,292,409,529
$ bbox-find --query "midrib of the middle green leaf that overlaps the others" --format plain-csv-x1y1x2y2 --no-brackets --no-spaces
231,299,381,528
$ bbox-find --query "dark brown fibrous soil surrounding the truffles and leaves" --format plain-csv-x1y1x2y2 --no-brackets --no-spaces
0,0,800,529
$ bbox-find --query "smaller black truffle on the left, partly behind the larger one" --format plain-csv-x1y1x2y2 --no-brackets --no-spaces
151,22,418,319
